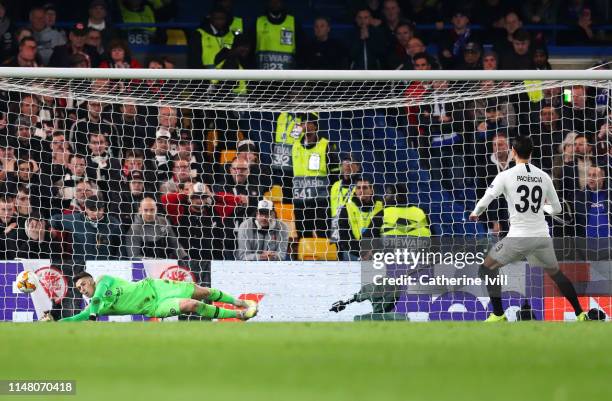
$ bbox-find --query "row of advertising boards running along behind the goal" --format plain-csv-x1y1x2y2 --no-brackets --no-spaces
0,260,612,322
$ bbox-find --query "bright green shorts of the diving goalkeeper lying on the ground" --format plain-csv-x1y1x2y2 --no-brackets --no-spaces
147,279,195,317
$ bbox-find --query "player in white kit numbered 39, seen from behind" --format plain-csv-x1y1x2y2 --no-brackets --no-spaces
470,136,588,322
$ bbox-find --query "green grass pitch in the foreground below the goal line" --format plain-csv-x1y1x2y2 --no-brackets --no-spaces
0,322,612,401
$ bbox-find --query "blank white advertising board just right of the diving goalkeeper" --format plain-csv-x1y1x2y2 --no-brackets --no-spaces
211,261,372,322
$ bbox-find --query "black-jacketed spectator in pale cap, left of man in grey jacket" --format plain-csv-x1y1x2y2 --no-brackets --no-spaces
178,183,224,262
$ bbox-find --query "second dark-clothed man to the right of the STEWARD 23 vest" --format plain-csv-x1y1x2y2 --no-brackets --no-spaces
349,8,387,70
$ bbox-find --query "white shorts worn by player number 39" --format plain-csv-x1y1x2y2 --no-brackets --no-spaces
489,237,559,270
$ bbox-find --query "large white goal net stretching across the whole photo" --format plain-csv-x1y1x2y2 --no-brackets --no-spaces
0,68,612,321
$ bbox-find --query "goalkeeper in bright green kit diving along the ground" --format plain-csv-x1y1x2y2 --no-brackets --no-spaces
42,272,257,322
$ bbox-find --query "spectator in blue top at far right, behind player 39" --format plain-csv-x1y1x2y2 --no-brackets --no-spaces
575,166,612,238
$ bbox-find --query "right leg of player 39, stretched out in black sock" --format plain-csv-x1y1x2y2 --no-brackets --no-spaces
527,238,588,320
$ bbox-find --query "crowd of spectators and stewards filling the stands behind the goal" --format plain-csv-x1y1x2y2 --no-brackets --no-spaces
0,0,612,270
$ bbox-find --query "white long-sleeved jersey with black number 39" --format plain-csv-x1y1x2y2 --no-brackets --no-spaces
473,163,561,237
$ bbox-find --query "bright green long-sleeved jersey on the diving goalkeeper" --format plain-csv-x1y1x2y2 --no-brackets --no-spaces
61,276,156,322
